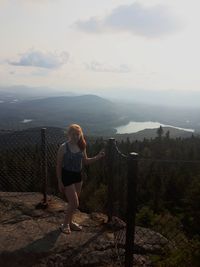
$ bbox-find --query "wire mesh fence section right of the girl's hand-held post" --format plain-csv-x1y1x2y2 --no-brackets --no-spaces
104,141,200,267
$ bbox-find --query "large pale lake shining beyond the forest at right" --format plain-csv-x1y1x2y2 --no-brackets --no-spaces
116,121,194,134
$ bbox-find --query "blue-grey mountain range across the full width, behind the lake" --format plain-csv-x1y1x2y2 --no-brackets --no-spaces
0,88,200,135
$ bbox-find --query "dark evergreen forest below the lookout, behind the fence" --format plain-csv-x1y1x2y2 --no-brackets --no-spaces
0,128,200,266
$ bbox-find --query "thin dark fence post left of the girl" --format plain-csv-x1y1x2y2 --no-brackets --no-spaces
41,128,47,205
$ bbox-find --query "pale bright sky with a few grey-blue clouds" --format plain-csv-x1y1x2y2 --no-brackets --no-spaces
0,0,200,96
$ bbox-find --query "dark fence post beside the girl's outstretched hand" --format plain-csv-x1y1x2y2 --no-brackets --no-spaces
106,138,115,221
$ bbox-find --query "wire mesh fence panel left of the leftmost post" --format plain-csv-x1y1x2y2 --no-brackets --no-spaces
0,129,42,192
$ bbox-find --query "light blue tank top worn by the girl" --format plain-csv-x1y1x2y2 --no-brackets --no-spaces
63,142,83,172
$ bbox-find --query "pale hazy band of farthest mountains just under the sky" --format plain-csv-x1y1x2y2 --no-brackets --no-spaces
0,85,200,108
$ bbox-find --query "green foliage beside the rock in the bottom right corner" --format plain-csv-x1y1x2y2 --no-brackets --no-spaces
137,211,200,267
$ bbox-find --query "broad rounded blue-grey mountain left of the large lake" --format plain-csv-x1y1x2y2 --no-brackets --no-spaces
0,95,125,134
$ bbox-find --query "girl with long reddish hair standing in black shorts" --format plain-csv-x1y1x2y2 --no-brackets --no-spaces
56,124,105,234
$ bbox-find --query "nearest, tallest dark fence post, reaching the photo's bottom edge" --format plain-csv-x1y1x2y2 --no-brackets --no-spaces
125,152,138,267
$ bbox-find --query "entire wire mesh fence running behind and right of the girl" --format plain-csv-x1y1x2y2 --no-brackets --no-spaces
0,128,200,267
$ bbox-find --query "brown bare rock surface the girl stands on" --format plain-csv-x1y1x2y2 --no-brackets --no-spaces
0,192,167,267
